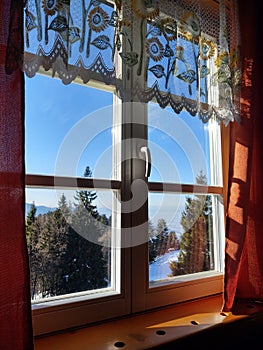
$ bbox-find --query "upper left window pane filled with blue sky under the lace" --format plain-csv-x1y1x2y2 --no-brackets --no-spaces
25,75,113,178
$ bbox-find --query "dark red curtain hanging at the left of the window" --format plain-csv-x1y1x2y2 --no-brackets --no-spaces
0,0,33,350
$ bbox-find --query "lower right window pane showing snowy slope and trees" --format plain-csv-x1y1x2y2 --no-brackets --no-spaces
149,193,223,285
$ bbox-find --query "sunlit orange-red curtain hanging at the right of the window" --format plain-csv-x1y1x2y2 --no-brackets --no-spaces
223,0,263,311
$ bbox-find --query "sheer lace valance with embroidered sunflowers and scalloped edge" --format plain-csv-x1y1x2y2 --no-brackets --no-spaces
7,0,241,124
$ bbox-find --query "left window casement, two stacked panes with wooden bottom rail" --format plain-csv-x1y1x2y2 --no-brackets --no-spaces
26,75,131,334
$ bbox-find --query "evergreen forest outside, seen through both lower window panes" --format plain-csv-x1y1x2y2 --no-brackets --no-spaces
26,167,213,300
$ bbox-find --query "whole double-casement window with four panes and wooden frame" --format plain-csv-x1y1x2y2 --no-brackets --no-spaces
26,2,229,334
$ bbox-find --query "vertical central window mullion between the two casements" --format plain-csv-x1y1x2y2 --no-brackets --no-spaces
131,14,152,312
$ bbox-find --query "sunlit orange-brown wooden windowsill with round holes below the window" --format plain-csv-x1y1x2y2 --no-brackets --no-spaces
35,295,263,350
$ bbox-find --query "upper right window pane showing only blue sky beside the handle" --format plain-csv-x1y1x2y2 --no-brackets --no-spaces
148,103,221,185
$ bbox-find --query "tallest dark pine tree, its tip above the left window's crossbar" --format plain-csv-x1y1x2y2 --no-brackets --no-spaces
62,167,108,293
